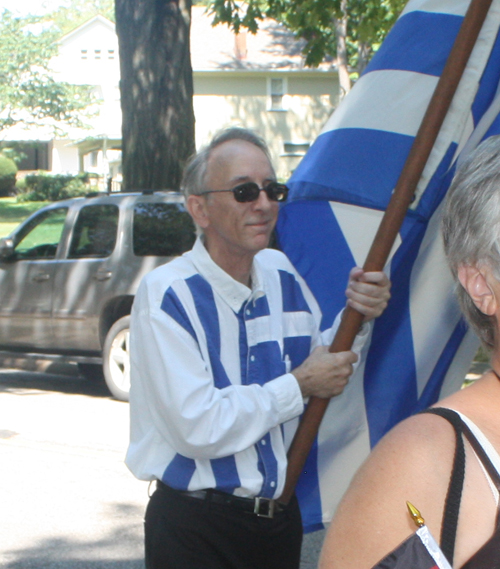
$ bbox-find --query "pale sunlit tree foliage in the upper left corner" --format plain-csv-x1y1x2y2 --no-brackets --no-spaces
0,11,92,134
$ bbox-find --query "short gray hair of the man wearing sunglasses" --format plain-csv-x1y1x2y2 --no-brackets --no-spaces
181,127,271,198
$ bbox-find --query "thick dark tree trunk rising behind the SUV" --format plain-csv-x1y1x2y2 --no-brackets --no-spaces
115,0,195,191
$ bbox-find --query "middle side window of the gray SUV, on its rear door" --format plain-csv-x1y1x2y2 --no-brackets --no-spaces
69,205,118,259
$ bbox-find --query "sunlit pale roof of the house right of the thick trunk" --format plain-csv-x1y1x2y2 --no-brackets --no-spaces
191,6,332,71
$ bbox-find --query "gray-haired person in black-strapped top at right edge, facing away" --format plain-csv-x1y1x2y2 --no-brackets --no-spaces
320,136,500,569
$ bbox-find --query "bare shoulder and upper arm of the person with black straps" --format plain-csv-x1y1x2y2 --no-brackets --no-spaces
320,414,455,569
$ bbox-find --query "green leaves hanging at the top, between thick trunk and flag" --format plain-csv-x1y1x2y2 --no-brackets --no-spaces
209,0,406,69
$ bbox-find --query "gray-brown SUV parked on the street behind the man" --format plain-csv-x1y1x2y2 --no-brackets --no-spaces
0,192,195,400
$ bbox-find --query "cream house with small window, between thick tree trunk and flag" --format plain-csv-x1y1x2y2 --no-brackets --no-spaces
191,6,339,180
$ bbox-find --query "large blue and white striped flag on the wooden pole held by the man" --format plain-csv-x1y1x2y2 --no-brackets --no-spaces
277,0,500,531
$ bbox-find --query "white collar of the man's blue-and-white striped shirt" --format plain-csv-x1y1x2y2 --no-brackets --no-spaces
188,236,264,312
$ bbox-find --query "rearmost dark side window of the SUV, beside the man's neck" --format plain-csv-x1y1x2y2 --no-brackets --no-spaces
133,202,196,257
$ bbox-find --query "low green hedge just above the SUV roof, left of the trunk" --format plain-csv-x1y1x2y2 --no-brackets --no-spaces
18,174,89,202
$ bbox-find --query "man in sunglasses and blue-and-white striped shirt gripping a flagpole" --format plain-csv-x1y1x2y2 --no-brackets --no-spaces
126,128,390,569
